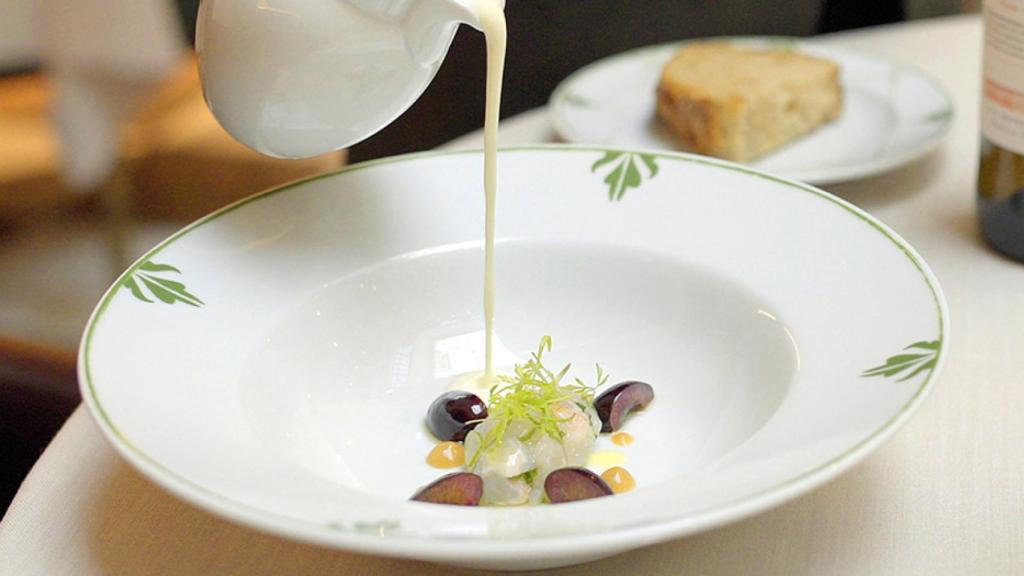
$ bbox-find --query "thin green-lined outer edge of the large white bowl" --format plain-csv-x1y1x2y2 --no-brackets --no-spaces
78,143,950,563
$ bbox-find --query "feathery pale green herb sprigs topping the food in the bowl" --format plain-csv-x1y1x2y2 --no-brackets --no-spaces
469,336,608,469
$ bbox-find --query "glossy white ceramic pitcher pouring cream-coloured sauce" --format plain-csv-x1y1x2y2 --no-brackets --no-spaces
196,0,495,158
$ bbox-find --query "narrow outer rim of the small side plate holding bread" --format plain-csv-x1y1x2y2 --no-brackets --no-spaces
547,35,957,186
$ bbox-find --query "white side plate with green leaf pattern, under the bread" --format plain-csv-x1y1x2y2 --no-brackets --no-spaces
550,38,953,184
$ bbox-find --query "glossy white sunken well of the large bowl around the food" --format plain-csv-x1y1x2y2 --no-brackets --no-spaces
242,242,795,500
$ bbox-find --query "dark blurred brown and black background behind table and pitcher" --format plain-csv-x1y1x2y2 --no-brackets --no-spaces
0,0,977,513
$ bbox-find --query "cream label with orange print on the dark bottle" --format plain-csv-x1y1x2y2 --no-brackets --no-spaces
981,0,1024,154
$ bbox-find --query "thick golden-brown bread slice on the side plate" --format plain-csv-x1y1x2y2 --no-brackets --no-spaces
657,41,843,162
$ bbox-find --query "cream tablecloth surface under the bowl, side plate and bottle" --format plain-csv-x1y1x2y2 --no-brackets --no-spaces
0,16,1024,576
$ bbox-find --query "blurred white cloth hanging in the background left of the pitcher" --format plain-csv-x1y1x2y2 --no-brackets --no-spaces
39,0,185,190
